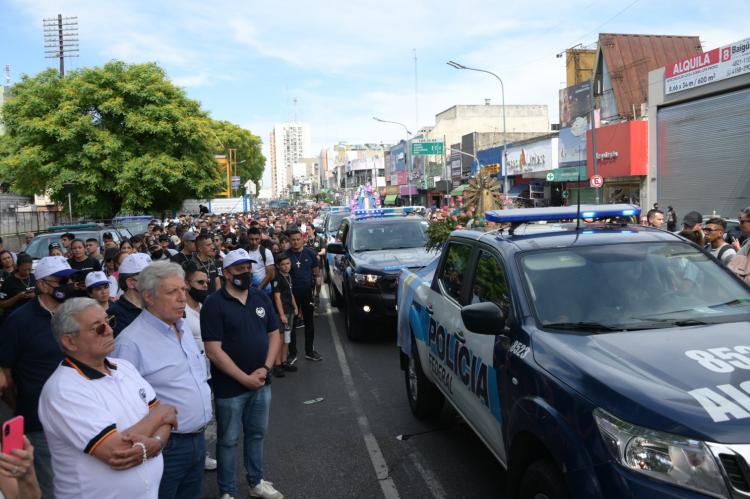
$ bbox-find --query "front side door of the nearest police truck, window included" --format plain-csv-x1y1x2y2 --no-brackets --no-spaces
459,246,512,462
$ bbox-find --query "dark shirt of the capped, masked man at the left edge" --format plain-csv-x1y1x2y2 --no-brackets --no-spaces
0,299,63,432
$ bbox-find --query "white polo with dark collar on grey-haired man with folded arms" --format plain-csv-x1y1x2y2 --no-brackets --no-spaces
39,357,164,499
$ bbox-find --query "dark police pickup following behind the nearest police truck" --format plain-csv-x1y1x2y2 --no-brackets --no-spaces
326,208,436,341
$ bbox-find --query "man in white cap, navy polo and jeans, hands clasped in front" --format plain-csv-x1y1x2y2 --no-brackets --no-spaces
201,249,283,499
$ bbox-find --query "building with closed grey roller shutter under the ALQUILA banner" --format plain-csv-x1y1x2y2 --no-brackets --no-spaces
644,39,750,219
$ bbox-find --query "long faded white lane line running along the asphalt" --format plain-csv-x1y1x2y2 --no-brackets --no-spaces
326,290,401,499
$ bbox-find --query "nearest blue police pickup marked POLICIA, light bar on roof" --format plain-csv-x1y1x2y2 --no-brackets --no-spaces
398,205,750,499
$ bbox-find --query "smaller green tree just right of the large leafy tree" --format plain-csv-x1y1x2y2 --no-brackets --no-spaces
210,120,266,193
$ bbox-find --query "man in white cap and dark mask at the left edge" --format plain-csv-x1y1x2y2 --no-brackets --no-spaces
0,256,77,497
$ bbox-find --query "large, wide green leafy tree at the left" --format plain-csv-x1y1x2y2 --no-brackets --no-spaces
0,61,228,217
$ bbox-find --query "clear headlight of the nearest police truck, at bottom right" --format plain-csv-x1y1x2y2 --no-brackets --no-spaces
593,408,729,497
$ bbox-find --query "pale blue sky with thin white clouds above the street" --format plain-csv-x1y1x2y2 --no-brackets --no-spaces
0,0,750,188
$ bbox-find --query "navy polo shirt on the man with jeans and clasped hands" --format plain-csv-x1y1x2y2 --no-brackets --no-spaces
201,288,279,398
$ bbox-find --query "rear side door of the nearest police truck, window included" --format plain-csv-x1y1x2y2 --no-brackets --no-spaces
428,239,476,434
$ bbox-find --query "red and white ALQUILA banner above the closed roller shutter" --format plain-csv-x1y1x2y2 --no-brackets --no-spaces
664,38,750,95
